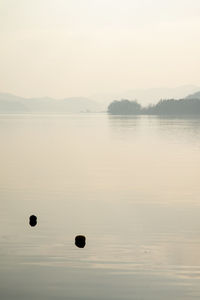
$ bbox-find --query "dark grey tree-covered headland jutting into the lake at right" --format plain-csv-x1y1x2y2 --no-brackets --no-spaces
108,92,200,115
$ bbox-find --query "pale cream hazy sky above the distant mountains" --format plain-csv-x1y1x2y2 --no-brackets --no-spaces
0,0,200,97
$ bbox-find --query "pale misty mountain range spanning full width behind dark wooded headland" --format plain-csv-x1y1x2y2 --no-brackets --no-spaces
0,86,200,113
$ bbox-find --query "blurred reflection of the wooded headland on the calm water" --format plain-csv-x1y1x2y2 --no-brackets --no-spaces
108,115,200,145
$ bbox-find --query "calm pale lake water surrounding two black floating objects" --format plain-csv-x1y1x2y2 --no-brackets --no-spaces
0,114,200,300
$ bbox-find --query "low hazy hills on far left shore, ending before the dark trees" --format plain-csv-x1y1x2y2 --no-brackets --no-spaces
0,93,102,113
